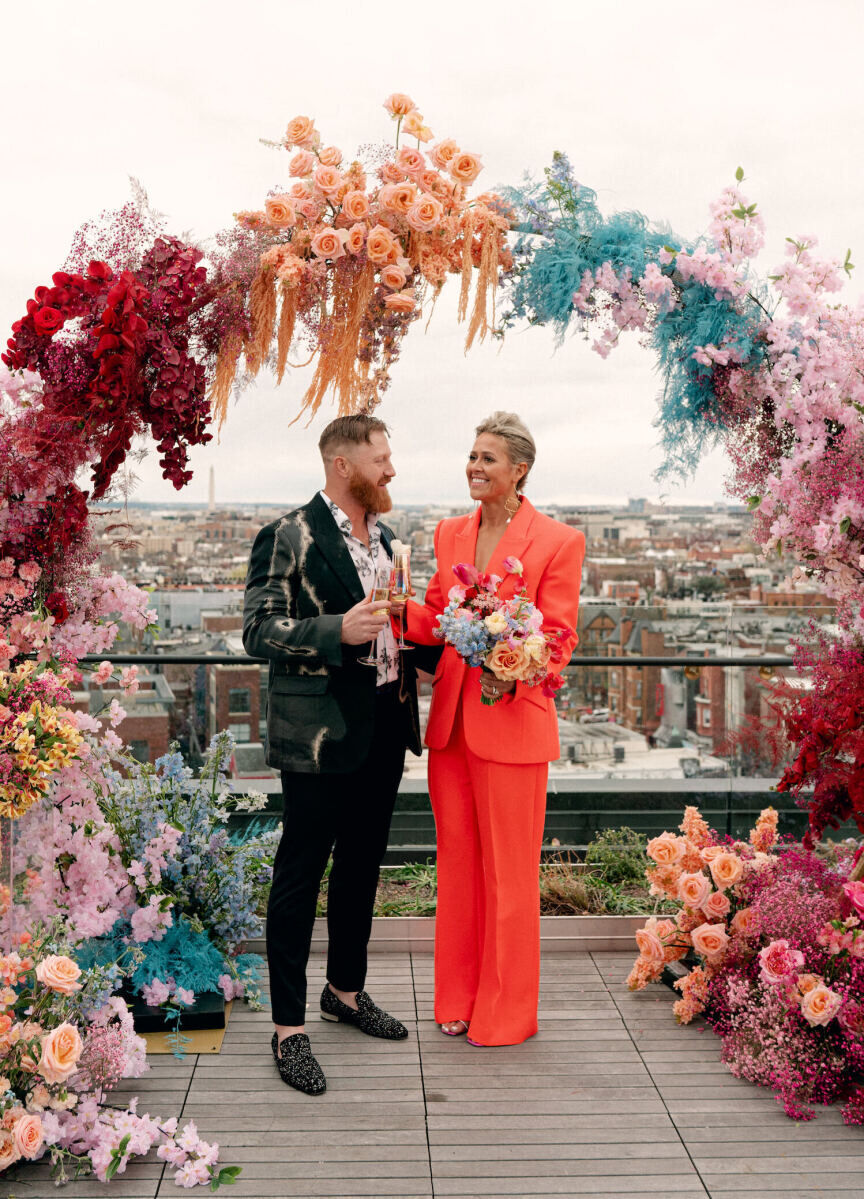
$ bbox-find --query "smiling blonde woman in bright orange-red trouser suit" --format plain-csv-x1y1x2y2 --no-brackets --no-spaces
406,412,585,1046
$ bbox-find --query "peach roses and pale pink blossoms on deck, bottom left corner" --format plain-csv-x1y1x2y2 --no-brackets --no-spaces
0,944,240,1191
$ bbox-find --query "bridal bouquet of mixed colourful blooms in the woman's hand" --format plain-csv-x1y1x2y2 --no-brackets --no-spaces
435,558,570,705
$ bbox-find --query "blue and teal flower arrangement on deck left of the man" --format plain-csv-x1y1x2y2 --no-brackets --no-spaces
81,733,278,1005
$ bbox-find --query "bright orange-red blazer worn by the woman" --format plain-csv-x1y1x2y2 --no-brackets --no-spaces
406,499,585,763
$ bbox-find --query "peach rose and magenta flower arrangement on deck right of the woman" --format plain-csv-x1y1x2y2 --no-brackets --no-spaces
628,807,864,1123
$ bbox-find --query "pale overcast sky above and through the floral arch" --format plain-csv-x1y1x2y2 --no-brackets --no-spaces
0,0,864,504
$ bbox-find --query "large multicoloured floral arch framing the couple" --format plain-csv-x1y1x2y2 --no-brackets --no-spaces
0,94,864,1182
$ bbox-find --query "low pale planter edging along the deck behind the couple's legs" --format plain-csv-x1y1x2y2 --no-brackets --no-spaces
247,912,649,954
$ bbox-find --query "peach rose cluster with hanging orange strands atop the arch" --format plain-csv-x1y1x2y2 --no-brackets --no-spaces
212,92,512,418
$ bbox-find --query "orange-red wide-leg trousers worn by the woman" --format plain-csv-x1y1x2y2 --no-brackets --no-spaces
429,705,549,1046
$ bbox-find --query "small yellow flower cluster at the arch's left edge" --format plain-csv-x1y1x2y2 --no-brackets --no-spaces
0,690,83,820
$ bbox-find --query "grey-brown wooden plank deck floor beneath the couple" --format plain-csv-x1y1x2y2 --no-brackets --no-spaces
13,953,864,1199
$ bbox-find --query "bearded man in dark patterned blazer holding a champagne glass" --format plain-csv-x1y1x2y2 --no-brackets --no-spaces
243,415,421,1095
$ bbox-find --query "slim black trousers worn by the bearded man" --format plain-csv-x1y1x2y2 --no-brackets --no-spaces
267,683,405,1025
